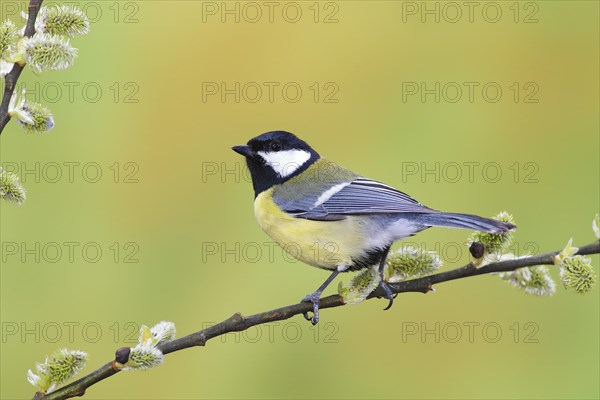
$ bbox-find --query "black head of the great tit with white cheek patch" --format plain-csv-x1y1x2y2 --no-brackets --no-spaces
232,131,319,196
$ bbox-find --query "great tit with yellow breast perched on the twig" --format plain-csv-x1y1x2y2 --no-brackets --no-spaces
232,131,516,324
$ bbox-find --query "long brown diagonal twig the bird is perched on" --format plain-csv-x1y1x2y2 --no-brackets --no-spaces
33,241,600,400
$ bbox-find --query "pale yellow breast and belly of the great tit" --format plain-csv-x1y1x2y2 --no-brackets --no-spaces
254,188,365,269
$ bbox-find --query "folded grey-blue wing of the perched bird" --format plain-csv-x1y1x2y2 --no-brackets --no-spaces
286,178,438,221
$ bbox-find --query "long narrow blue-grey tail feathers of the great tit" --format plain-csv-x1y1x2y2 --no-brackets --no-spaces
419,212,517,233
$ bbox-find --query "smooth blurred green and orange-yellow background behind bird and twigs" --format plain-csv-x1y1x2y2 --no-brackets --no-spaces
0,1,600,399
